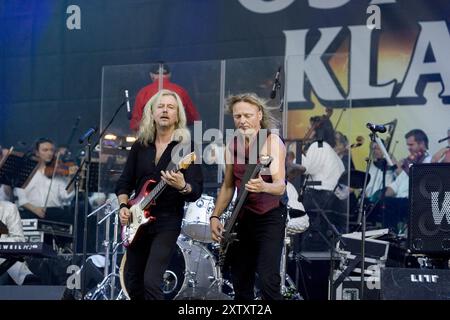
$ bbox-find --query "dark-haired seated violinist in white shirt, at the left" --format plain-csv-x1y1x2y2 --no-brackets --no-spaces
14,138,77,223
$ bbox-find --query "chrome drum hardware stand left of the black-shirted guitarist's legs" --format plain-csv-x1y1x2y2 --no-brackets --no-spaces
85,200,125,300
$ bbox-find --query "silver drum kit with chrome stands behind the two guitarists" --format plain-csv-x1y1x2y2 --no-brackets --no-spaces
87,194,298,300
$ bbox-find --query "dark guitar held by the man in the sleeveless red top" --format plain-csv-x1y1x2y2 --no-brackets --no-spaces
217,156,272,268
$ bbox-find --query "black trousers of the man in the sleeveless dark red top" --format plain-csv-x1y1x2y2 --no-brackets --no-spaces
230,206,287,300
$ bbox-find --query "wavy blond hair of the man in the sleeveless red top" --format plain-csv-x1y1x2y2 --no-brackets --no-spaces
226,92,279,129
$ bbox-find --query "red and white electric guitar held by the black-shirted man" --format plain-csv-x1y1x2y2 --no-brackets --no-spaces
122,152,196,247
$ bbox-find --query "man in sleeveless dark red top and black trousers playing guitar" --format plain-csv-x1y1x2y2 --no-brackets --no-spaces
211,94,287,300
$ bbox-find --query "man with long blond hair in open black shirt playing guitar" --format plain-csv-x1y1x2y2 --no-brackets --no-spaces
116,90,203,300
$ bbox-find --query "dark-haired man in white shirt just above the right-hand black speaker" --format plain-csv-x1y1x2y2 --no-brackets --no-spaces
386,129,431,198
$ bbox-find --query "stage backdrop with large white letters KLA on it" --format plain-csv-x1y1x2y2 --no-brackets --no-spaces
0,0,450,168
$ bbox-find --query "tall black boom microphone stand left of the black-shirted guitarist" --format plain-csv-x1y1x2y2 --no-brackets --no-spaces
66,96,126,300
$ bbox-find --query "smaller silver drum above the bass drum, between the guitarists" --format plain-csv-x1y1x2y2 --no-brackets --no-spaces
182,195,214,243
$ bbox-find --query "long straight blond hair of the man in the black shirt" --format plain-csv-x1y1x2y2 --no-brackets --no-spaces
138,89,191,146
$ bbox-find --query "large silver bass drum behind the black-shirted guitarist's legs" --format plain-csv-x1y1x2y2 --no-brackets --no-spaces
119,236,217,300
